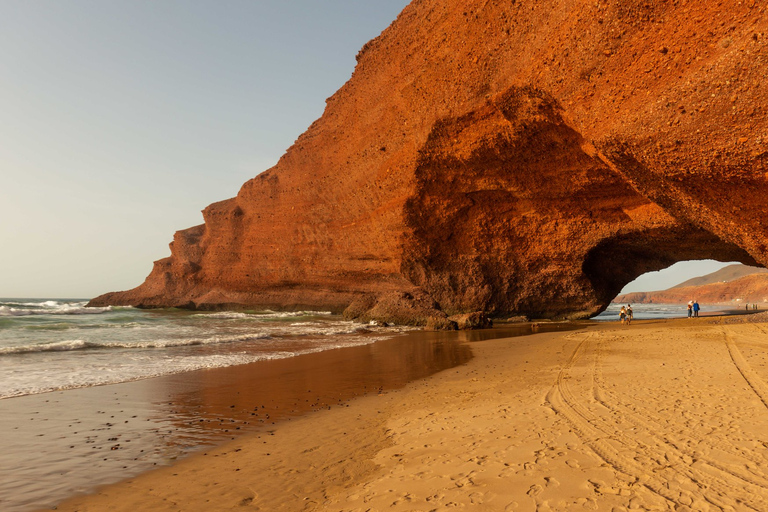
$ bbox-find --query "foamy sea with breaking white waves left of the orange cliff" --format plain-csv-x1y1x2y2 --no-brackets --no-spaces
0,299,420,399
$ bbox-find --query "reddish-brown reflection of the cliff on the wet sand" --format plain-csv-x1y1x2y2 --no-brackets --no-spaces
157,332,471,443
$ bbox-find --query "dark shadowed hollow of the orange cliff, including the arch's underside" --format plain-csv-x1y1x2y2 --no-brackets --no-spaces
403,88,756,317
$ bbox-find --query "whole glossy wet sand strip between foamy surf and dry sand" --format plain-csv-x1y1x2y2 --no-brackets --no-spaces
0,332,471,512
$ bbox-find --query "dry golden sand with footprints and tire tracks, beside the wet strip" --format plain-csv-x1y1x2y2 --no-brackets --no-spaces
49,319,768,512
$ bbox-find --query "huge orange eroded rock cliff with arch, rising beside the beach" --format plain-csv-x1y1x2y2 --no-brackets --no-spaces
92,0,768,323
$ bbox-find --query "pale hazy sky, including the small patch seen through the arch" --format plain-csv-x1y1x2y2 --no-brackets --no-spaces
0,0,732,298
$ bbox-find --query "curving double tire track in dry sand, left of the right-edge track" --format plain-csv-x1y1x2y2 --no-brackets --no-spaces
547,333,768,511
